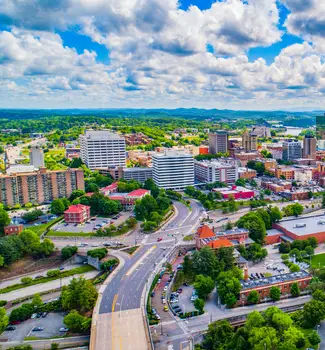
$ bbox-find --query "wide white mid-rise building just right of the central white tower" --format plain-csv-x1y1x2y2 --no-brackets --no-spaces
194,160,238,184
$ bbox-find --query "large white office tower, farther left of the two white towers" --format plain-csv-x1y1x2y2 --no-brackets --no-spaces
79,130,126,170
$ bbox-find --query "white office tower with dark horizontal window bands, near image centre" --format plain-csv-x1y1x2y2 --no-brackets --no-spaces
152,151,194,189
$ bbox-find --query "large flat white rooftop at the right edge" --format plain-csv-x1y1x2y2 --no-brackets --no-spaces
277,215,325,236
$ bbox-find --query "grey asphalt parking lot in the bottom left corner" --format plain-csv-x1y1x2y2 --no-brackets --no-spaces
1,312,65,341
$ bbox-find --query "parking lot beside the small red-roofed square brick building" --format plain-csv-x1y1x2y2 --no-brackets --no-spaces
53,212,132,233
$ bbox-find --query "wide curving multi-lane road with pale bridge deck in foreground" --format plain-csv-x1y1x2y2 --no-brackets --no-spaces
92,201,203,350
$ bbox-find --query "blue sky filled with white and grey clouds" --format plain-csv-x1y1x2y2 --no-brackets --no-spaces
0,0,325,110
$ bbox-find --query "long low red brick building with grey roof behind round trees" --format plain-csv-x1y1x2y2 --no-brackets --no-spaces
238,270,312,305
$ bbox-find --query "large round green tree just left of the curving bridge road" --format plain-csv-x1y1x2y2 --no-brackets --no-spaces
61,277,97,312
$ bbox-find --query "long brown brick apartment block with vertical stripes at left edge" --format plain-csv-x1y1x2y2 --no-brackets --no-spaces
0,168,85,206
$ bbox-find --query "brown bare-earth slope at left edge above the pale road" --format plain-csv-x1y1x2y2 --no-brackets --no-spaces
0,252,62,280
